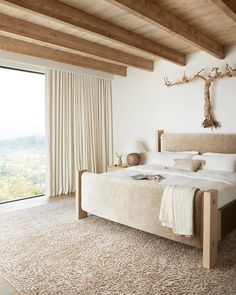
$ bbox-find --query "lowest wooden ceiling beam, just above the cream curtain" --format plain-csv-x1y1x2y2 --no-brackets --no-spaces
0,36,127,76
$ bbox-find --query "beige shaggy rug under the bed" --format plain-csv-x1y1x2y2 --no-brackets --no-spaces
0,198,236,295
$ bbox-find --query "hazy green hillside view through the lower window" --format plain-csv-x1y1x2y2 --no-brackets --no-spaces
0,136,46,202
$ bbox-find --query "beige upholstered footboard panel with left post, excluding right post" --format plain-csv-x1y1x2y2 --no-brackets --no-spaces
76,171,203,248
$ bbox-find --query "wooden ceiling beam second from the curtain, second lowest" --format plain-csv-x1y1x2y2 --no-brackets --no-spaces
0,13,154,71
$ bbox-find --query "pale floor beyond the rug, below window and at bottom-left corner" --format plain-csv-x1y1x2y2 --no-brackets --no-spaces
0,194,74,295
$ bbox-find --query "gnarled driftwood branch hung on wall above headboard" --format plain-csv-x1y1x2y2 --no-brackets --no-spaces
164,64,236,128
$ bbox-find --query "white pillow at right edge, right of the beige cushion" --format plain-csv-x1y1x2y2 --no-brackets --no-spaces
193,153,236,172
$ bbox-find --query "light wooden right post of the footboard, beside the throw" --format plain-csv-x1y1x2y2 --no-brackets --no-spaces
203,190,218,269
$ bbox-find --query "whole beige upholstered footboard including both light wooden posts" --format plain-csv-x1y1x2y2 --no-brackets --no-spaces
76,170,221,269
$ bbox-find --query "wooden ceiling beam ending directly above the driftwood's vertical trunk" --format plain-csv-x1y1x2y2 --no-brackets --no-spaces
106,0,225,59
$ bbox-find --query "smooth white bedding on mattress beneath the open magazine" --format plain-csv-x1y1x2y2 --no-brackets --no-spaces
104,164,236,208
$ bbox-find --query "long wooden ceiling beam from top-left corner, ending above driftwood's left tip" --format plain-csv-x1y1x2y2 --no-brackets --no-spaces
0,0,186,65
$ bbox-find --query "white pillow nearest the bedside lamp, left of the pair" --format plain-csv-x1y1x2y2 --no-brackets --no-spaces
146,152,196,168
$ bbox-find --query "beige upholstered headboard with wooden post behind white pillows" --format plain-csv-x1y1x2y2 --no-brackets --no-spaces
156,130,236,154
